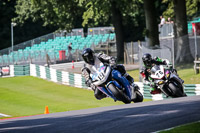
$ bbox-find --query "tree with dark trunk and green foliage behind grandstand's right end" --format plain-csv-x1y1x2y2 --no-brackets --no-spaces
80,0,142,62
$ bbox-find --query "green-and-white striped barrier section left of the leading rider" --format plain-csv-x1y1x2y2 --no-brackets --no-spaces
10,64,86,89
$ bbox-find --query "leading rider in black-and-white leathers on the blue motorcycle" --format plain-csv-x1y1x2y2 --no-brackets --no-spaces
82,48,136,100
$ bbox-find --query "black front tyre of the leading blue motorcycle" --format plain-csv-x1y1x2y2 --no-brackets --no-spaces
108,84,131,104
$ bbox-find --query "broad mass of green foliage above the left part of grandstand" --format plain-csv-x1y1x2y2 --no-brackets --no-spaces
14,0,83,30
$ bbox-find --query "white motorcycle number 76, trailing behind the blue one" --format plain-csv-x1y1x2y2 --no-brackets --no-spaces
150,65,186,98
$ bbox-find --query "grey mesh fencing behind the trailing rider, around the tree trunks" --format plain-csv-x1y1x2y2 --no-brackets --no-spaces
125,24,200,74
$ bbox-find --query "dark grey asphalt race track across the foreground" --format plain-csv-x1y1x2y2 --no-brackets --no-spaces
0,96,200,133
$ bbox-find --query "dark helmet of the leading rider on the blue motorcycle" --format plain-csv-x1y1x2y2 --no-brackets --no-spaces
82,48,94,65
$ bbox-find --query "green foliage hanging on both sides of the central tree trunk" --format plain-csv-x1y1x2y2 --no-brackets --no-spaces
79,0,143,26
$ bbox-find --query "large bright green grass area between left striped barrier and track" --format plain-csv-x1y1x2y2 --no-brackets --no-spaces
0,76,150,119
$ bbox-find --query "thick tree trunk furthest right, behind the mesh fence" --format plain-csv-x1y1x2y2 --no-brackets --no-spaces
173,0,193,63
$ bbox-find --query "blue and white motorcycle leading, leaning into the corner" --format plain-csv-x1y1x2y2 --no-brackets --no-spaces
91,63,143,104
